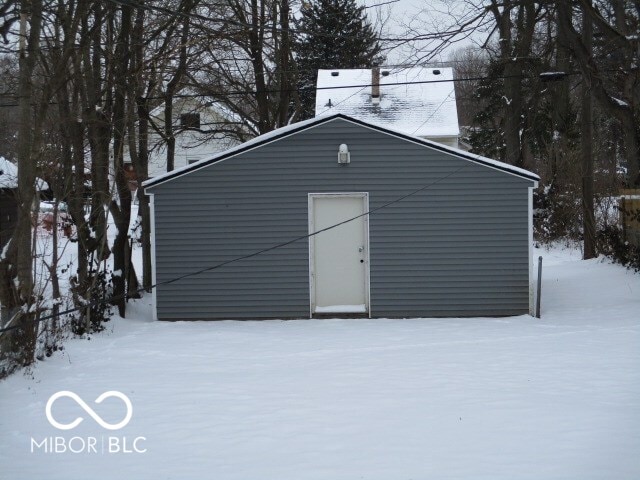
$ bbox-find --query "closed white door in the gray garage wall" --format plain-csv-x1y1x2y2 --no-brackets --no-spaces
309,193,369,314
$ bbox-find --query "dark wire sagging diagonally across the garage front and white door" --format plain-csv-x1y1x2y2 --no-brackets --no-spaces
0,164,467,334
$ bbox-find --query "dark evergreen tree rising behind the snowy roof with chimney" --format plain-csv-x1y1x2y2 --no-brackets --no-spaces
295,0,384,120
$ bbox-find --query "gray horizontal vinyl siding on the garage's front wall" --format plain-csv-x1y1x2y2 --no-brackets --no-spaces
149,119,532,320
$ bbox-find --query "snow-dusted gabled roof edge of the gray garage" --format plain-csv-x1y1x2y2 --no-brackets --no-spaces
142,113,540,188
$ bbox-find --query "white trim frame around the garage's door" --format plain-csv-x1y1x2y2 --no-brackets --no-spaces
307,192,371,318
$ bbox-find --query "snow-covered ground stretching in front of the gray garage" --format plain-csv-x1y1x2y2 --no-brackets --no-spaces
0,246,640,480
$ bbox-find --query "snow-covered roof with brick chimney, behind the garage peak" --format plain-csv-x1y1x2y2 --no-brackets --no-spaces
316,67,460,137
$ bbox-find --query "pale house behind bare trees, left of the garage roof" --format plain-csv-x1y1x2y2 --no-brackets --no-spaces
124,92,241,183
